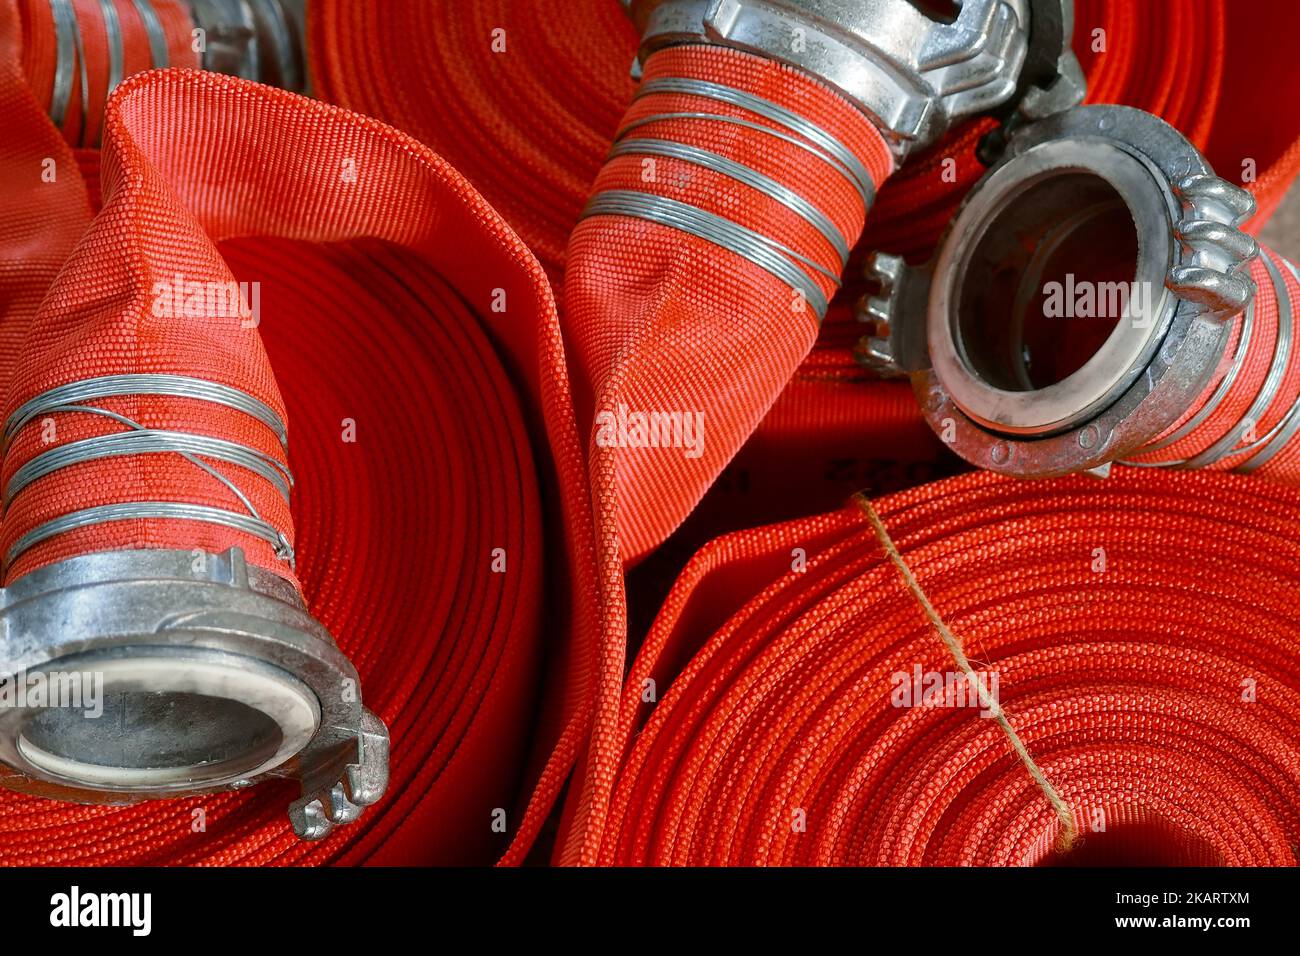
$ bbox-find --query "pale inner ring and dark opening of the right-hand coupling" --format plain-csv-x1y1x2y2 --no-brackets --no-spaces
927,139,1175,437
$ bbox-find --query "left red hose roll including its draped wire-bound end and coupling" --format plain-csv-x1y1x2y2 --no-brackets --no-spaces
0,50,595,864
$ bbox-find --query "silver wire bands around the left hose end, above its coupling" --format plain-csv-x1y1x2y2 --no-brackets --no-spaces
4,375,296,567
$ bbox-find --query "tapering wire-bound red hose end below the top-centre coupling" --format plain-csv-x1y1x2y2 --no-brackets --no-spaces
563,46,893,559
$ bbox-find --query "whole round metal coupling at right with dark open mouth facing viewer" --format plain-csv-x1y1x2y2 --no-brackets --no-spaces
857,105,1263,477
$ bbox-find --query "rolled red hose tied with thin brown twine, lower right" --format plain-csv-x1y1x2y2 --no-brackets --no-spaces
582,468,1300,866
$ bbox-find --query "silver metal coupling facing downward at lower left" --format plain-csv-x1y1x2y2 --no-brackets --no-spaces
0,549,389,840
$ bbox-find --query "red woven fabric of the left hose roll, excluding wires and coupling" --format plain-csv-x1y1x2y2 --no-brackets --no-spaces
0,72,613,864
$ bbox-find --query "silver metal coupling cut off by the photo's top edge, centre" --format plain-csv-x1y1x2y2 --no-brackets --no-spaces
624,0,1084,161
